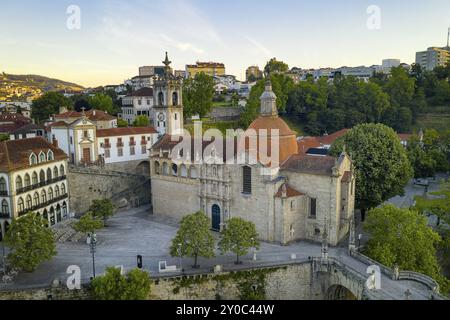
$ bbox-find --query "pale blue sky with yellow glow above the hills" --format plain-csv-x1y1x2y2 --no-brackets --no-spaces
0,0,450,87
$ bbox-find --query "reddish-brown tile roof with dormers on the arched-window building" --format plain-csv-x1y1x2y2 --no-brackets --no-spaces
0,137,67,172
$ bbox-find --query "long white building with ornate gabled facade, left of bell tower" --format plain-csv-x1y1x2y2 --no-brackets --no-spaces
50,115,158,165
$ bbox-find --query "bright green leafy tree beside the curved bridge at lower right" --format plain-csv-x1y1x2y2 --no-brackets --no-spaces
364,205,447,290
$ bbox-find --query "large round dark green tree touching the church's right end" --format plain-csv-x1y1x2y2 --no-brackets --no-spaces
331,124,413,220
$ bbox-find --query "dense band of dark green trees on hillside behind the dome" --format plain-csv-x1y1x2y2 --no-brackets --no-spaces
241,59,450,135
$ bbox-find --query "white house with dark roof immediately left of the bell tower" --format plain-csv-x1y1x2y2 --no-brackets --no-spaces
121,88,154,125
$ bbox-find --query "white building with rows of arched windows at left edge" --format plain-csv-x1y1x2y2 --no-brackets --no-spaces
0,137,69,239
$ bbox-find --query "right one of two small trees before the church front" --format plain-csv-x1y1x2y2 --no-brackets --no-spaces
219,218,259,264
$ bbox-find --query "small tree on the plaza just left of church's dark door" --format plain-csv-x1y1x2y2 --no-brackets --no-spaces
170,211,214,268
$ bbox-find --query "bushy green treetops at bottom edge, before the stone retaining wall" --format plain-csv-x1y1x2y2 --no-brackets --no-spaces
92,267,152,300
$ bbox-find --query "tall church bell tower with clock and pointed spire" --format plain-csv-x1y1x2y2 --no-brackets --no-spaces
153,52,184,135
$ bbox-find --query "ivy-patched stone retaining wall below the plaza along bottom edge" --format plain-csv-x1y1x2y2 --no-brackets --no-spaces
0,262,327,300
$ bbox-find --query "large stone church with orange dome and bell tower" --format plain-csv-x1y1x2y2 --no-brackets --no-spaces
150,56,356,246
